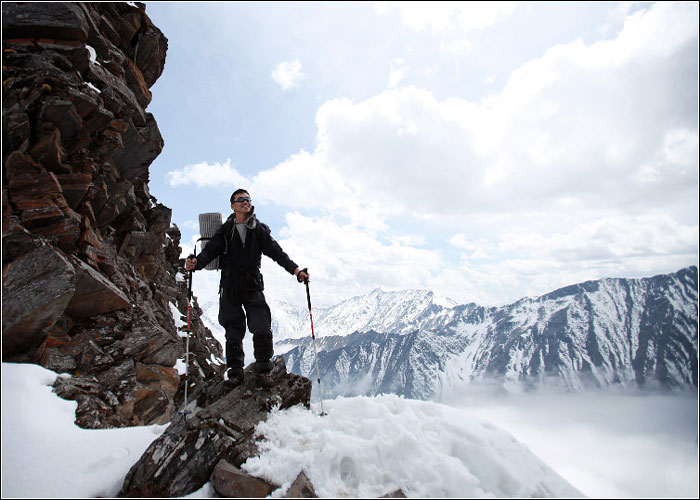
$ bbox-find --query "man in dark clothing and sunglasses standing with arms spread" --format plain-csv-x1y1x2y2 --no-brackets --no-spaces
185,189,309,388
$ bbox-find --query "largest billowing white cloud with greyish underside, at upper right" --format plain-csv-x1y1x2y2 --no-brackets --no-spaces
308,0,697,219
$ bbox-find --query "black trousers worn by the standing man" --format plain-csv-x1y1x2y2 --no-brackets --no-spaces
219,288,274,372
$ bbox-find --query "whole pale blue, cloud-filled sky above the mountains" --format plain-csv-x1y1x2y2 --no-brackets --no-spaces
146,2,698,305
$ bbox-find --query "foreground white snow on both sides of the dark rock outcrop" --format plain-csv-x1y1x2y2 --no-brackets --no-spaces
2,363,582,498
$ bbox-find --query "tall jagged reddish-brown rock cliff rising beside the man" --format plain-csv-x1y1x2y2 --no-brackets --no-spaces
2,2,223,428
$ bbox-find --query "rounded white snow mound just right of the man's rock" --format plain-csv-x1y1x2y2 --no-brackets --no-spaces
241,395,582,498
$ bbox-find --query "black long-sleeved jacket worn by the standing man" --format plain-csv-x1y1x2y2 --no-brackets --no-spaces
196,214,297,290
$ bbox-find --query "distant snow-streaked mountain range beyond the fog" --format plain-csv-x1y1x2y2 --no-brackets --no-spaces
280,266,698,399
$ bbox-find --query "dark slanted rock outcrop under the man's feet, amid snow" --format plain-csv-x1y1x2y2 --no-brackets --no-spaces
120,357,311,497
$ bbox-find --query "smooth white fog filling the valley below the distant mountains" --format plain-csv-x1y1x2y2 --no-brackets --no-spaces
442,389,698,498
